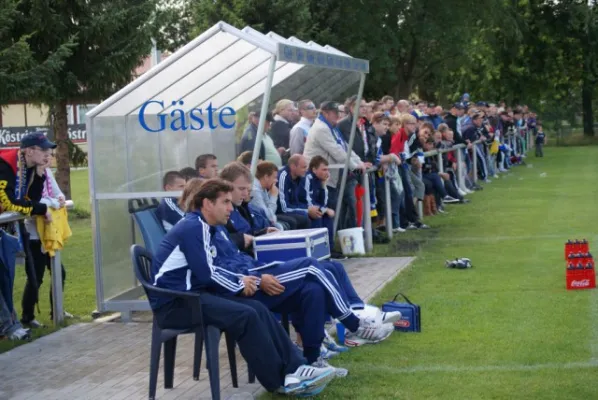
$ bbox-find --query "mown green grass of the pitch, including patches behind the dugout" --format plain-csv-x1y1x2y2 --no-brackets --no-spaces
0,147,598,400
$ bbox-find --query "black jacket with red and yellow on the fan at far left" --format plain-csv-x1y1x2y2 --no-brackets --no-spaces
0,149,48,215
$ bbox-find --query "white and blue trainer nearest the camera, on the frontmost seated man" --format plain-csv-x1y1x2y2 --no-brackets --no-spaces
278,365,336,397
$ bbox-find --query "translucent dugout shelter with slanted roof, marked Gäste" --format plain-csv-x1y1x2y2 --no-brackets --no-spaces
87,22,369,321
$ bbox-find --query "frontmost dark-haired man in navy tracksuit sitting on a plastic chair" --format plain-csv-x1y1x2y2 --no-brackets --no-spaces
149,179,334,396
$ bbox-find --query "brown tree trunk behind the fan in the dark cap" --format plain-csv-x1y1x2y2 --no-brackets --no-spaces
53,101,71,200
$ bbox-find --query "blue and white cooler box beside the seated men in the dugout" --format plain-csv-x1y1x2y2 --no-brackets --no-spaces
253,228,330,263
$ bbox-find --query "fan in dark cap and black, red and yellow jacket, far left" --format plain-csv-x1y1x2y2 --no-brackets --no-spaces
0,133,56,328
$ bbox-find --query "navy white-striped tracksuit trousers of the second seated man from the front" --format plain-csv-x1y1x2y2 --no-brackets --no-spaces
250,257,359,364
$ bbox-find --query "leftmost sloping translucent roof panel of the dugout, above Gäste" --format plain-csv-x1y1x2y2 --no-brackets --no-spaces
100,32,239,116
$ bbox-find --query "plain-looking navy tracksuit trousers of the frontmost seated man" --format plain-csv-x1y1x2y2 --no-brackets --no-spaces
154,293,306,392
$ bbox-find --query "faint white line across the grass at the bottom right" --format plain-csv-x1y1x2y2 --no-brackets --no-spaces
345,360,598,374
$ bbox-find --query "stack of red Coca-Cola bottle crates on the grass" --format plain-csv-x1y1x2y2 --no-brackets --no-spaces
565,240,596,290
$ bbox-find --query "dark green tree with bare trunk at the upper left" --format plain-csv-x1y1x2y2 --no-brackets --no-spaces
11,0,156,197
